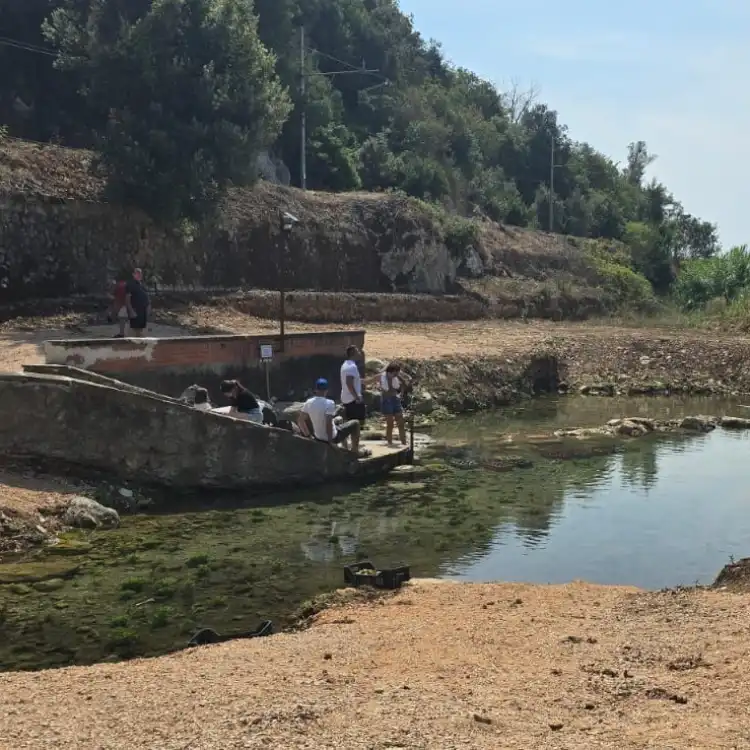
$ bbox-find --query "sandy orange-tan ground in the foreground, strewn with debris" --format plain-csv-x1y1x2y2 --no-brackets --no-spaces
0,582,750,750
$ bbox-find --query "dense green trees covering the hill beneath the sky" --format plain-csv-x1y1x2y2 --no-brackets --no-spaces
0,0,718,300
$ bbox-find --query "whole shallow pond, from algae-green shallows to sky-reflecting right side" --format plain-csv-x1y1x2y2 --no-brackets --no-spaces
0,398,750,669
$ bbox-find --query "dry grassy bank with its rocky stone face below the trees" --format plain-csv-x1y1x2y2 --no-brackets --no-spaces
0,139,649,317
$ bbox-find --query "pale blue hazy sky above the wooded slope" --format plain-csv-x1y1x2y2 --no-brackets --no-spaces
400,0,750,247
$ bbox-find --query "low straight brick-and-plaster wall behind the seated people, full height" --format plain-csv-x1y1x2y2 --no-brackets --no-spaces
44,331,365,400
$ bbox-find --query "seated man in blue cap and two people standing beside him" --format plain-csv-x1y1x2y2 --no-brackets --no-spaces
297,346,409,454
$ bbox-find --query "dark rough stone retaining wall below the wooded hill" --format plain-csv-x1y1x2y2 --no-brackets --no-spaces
0,185,468,305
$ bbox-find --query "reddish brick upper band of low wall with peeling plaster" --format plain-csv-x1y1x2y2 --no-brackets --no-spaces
44,331,365,375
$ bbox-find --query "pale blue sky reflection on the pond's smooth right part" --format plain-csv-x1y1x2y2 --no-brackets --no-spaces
442,430,750,588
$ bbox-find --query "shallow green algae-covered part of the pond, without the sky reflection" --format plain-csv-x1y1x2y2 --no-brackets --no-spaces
0,399,740,670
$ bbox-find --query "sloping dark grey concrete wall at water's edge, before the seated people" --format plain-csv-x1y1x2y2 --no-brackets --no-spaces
0,374,356,489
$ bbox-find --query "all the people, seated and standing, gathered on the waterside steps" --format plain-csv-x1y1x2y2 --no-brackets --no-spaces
181,346,409,455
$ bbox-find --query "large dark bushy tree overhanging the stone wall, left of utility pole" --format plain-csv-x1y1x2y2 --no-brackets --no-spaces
47,0,289,222
